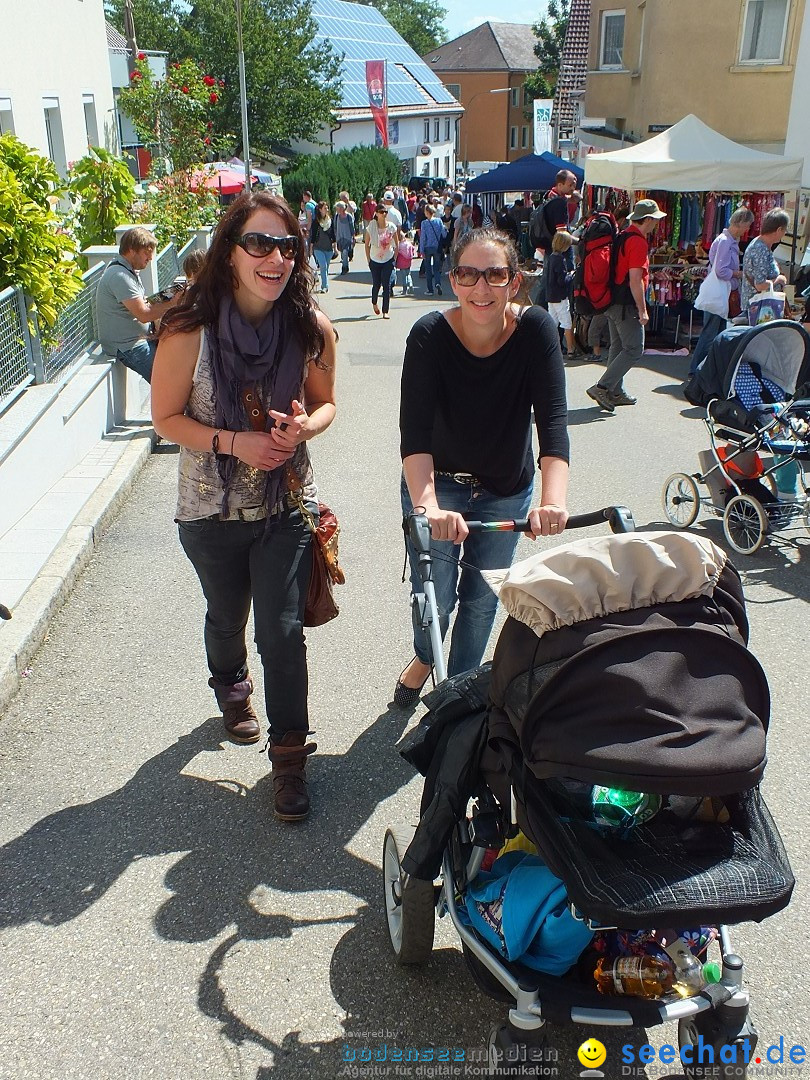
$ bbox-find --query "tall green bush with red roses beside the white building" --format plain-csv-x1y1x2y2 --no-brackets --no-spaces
120,53,232,173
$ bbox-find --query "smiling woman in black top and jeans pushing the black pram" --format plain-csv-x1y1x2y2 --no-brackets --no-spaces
393,228,568,707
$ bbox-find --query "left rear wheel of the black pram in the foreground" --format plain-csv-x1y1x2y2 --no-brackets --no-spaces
382,827,436,964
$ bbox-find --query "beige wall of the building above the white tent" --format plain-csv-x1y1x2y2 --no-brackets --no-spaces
585,0,808,153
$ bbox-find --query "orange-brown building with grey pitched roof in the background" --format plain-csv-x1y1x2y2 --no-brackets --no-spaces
424,22,538,167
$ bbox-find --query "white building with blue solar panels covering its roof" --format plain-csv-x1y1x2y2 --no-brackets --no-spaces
294,0,463,181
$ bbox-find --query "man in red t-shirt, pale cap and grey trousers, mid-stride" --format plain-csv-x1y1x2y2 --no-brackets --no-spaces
585,199,666,413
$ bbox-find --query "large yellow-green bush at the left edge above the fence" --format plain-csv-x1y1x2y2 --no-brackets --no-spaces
0,135,82,340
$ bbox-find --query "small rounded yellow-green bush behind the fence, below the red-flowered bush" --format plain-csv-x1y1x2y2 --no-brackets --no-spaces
68,146,135,247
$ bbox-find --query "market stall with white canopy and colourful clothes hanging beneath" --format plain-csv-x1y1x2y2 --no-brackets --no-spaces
585,113,804,340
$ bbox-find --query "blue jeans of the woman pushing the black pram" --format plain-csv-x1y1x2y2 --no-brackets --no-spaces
401,476,532,675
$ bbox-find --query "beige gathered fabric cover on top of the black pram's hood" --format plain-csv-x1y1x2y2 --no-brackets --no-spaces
483,532,727,637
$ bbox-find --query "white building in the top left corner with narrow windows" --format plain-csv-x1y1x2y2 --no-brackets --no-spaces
0,0,118,170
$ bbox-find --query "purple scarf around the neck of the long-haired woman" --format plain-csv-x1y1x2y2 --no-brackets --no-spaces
208,295,306,514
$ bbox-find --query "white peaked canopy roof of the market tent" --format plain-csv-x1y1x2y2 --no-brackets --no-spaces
585,112,804,191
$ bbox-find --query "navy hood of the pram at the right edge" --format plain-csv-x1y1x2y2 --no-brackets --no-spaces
696,319,810,401
